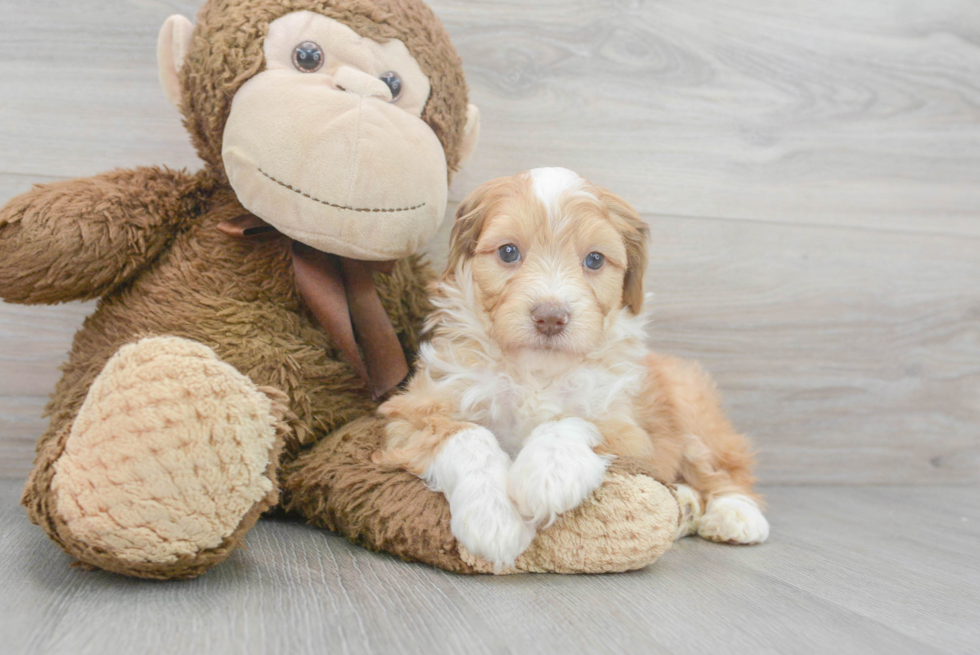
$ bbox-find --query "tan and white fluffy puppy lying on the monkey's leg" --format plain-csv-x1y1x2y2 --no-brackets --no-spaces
376,168,769,566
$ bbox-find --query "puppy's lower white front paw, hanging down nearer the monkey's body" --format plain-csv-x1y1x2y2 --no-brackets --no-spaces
449,484,535,572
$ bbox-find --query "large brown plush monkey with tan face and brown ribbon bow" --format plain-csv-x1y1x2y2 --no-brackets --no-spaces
0,0,678,579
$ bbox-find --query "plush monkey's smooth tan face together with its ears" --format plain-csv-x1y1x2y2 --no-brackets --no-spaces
159,0,479,260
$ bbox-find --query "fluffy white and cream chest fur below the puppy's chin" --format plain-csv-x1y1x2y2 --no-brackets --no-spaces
418,276,648,455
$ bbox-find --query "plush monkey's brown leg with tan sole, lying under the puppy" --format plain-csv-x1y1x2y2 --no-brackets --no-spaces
281,416,679,573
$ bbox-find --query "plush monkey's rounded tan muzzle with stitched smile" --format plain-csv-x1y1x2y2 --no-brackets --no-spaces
222,71,448,261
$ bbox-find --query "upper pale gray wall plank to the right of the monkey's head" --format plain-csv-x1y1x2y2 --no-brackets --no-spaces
432,0,980,236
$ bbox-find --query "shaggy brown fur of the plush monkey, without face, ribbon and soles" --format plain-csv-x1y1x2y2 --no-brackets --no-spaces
0,0,676,579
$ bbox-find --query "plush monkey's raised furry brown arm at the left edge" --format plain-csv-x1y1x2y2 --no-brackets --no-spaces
0,167,202,304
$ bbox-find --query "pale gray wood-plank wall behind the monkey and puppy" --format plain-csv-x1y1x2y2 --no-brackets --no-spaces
0,0,980,484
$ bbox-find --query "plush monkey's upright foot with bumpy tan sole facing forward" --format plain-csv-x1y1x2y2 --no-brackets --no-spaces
23,337,284,579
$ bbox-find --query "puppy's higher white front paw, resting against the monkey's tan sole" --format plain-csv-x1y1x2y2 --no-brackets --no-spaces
507,418,610,526
